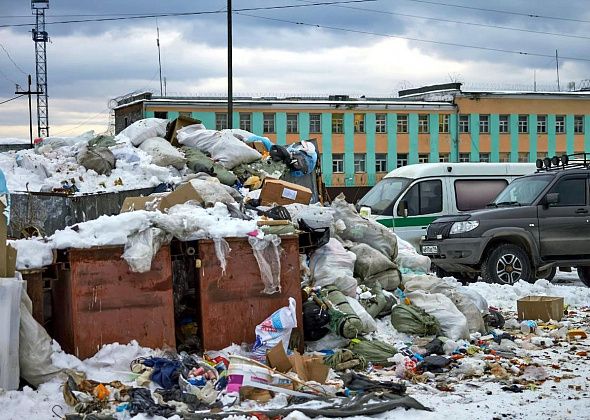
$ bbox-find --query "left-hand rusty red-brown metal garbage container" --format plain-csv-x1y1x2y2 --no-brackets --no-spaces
53,246,176,359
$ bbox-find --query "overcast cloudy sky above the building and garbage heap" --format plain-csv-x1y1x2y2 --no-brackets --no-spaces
0,0,590,138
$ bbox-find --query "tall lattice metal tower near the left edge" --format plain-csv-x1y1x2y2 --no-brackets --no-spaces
31,0,49,137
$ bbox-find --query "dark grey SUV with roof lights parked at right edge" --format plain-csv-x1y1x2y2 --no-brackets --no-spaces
421,153,590,287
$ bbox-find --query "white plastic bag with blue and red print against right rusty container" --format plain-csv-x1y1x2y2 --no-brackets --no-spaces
252,297,297,360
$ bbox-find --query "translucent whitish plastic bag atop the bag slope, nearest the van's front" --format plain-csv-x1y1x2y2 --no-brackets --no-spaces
332,194,397,260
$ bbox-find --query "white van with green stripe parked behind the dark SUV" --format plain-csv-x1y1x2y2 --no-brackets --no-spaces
358,163,537,249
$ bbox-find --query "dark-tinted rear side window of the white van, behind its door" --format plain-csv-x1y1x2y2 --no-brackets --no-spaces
455,179,508,211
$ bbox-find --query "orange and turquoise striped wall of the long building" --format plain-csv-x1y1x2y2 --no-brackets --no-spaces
138,97,590,187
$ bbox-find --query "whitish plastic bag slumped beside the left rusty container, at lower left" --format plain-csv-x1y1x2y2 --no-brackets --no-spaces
19,291,62,386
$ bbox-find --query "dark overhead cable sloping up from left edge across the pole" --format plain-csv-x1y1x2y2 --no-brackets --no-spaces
0,0,376,28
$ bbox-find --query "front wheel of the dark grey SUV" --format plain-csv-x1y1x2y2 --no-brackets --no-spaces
481,244,534,285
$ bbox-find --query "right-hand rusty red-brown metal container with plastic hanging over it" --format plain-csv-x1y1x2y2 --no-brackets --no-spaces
197,235,303,350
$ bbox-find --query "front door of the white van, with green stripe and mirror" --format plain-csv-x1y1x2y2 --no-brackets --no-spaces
394,178,446,249
